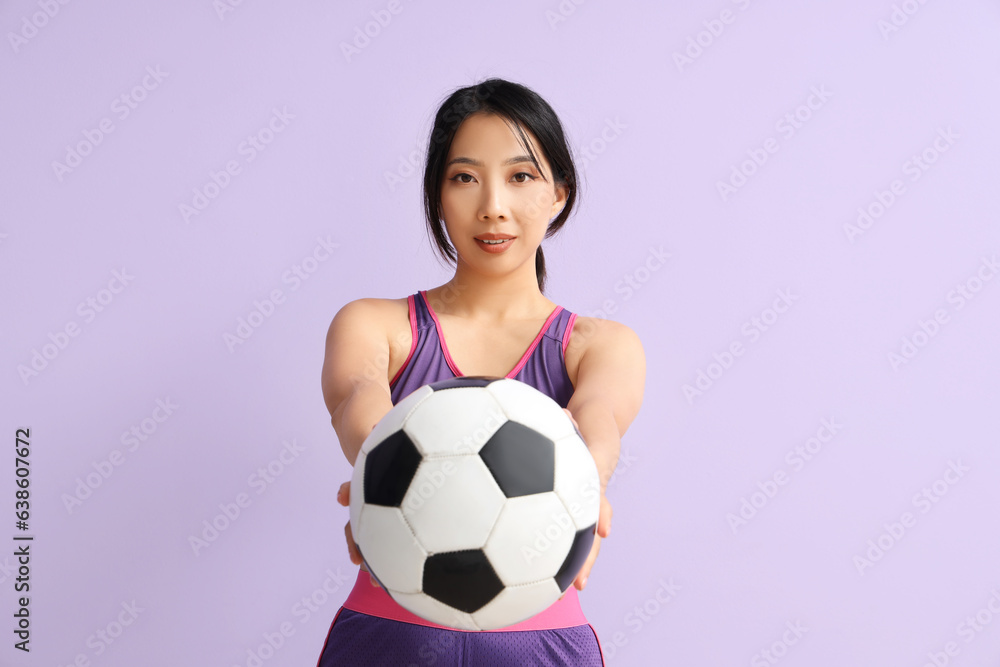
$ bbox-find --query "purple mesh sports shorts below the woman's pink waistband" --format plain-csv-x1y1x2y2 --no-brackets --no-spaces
317,607,604,667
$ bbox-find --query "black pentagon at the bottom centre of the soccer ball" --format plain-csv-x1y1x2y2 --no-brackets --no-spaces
423,549,503,614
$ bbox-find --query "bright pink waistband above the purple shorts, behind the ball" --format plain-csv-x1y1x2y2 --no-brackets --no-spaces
344,567,588,632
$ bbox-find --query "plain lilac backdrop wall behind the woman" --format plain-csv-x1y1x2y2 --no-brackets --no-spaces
0,0,1000,667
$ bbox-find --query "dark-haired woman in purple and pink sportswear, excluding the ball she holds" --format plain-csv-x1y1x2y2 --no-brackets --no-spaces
318,79,646,667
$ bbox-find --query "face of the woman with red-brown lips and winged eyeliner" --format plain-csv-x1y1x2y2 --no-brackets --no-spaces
441,113,566,275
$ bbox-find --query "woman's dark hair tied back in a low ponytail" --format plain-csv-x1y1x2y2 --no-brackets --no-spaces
424,78,577,292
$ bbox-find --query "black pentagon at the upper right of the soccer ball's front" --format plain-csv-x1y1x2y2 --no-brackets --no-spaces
479,421,556,498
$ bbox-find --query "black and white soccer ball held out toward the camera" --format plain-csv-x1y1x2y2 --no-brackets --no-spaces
350,376,600,630
